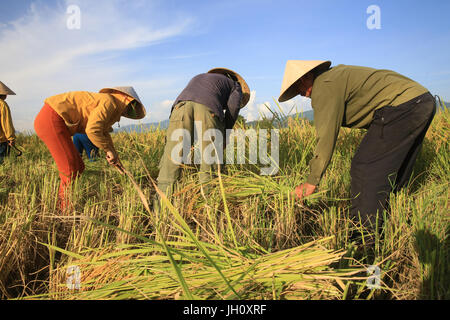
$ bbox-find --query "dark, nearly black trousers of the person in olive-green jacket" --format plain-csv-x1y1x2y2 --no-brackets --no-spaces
350,93,436,227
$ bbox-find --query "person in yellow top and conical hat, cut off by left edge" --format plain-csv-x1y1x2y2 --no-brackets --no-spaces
0,81,16,163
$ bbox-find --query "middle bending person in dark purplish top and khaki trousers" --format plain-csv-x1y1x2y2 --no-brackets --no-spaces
157,68,250,194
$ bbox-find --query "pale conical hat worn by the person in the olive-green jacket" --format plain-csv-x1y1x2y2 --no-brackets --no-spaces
278,60,331,102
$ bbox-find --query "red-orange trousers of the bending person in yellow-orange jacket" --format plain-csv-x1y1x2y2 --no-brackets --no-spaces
34,104,84,208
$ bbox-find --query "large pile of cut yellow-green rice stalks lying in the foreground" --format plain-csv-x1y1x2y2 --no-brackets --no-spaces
31,238,365,300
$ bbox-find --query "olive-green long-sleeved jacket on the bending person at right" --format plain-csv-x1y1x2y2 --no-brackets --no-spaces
307,65,428,185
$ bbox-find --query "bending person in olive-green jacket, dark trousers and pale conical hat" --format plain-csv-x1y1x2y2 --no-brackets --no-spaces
278,60,436,230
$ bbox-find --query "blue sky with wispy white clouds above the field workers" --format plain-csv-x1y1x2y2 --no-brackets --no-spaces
0,0,450,130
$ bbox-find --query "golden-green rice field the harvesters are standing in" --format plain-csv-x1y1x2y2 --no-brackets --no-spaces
0,110,450,300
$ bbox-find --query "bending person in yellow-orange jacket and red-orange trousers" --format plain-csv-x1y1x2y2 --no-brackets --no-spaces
34,87,146,210
